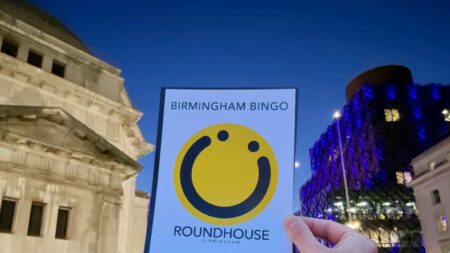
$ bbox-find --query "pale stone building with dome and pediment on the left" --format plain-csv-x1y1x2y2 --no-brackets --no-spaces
0,0,153,253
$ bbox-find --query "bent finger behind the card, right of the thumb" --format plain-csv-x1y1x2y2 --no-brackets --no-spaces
300,217,355,244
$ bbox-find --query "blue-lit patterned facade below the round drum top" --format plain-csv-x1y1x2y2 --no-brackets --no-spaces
300,84,450,249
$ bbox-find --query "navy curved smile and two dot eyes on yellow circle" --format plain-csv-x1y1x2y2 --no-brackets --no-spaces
180,130,271,218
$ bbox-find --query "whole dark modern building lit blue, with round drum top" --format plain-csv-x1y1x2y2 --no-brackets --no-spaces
300,66,450,252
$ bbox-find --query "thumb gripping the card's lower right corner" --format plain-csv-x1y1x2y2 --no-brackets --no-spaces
284,215,327,252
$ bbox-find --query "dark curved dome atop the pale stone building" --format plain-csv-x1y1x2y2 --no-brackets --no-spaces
0,0,89,53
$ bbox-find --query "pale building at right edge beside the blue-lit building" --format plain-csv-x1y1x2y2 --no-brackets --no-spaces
408,137,450,253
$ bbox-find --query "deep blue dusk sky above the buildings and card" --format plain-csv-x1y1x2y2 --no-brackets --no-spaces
27,0,450,210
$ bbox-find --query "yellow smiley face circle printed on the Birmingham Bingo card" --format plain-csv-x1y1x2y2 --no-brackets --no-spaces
174,124,278,225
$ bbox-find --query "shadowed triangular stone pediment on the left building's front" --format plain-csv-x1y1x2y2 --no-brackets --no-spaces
0,105,141,172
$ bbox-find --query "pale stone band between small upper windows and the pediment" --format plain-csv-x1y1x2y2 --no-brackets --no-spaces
0,53,151,159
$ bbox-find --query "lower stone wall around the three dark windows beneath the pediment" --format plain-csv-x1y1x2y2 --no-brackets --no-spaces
0,171,120,253
